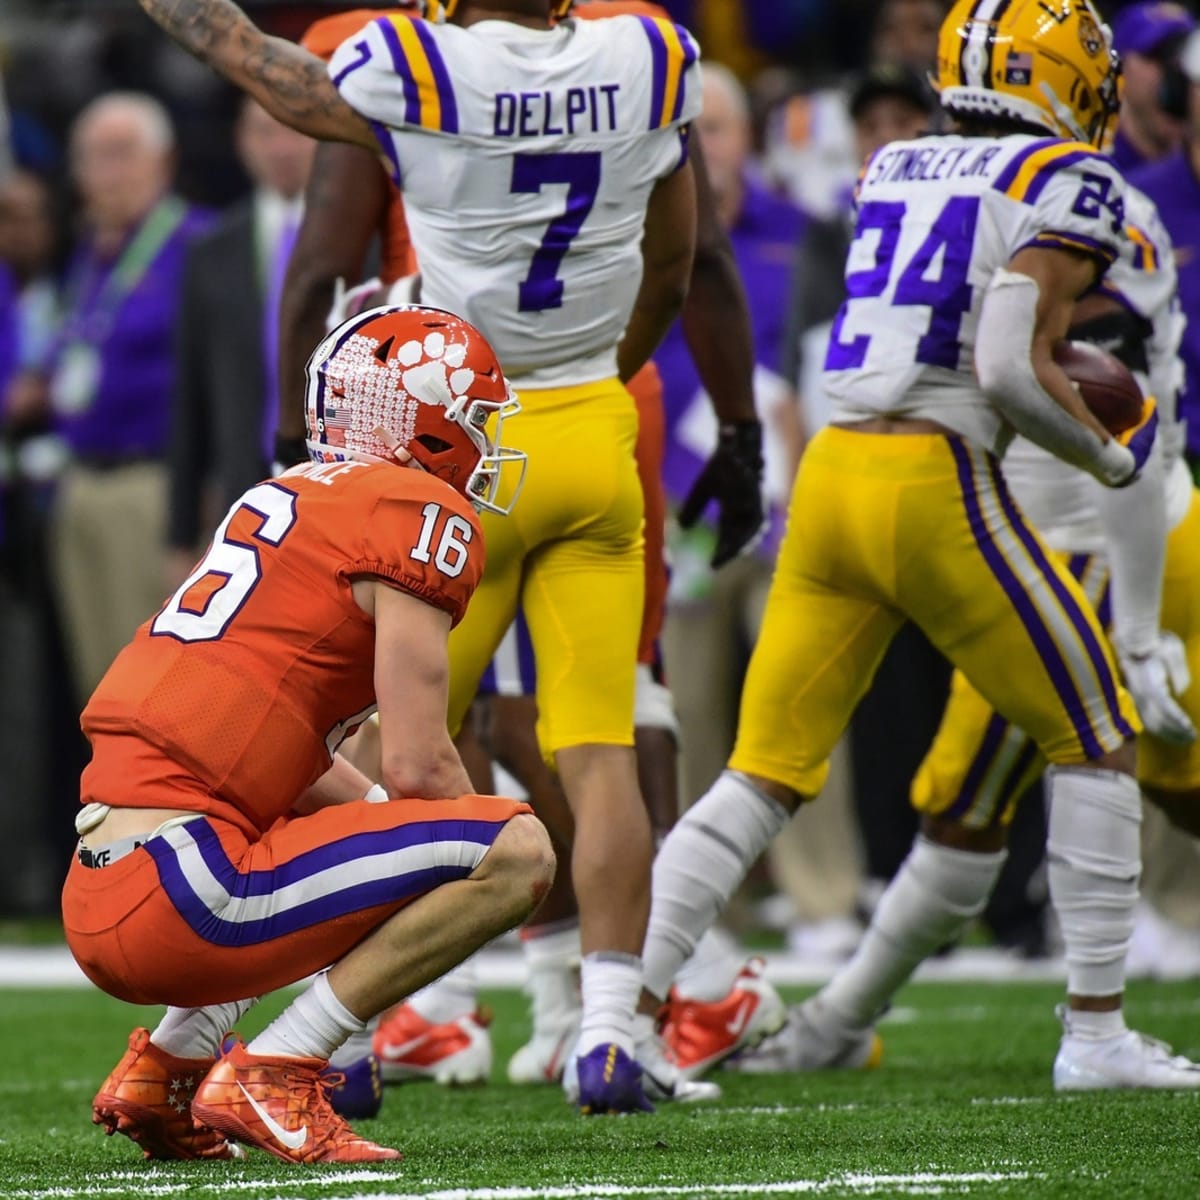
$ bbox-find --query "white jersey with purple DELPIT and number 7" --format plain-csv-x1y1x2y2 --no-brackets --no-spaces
329,13,701,386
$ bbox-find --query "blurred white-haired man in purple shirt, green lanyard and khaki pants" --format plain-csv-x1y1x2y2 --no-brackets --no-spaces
46,92,206,698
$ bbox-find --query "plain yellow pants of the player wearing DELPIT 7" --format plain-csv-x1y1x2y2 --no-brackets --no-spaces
449,379,644,757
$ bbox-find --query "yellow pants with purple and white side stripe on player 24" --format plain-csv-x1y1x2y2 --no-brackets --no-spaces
730,427,1138,797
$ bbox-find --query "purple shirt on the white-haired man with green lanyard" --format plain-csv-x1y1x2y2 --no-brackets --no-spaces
48,199,211,458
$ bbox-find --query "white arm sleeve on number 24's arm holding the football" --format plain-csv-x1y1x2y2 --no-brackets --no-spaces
976,270,1136,487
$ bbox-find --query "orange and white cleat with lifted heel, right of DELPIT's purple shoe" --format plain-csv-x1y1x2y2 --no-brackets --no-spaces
660,958,787,1079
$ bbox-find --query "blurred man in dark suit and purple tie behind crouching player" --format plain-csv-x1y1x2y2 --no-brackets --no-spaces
167,98,314,578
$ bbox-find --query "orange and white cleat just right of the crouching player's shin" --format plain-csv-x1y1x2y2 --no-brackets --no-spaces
373,1004,492,1084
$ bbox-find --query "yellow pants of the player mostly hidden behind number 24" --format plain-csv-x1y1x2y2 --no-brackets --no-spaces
912,482,1200,829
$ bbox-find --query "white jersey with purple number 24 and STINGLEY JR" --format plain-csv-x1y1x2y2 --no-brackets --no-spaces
824,134,1126,454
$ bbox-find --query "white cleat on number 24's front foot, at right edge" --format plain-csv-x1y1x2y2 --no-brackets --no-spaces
1054,1004,1200,1092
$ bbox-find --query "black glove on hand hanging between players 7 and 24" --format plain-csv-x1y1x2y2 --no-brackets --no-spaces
679,421,767,568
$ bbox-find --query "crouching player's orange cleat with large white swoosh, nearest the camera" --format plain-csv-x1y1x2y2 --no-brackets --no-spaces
192,1040,401,1163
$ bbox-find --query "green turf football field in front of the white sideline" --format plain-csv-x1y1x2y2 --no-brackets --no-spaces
0,984,1200,1200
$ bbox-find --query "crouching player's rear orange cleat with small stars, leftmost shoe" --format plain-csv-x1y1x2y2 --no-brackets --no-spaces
91,1028,245,1158
